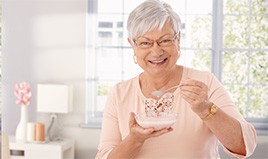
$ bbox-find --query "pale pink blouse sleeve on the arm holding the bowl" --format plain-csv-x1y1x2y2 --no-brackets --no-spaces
96,89,121,159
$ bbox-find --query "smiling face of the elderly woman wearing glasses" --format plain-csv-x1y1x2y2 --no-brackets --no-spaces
128,22,180,76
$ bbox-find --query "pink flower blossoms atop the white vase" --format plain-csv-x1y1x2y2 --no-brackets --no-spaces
15,82,32,106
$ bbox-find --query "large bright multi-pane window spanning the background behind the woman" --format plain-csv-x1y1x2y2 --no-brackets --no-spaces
82,0,268,133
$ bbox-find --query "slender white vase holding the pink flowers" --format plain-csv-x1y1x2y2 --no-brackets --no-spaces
16,105,28,142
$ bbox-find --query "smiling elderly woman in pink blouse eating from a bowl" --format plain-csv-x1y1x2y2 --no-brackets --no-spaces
96,0,256,159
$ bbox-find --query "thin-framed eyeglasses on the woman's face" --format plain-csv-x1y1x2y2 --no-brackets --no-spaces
132,33,178,49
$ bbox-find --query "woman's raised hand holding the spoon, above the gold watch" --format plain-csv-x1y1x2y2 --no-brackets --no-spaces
180,79,211,116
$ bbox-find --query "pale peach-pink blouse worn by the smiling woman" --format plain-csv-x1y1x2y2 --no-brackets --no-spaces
96,67,256,159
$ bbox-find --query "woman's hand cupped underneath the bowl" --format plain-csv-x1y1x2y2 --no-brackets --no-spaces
129,112,173,143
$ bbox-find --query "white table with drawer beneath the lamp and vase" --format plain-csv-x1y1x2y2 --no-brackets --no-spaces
9,136,74,159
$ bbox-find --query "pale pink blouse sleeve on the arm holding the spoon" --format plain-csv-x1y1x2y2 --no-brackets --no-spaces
209,75,256,158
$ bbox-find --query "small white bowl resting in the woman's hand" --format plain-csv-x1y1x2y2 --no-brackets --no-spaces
135,113,177,131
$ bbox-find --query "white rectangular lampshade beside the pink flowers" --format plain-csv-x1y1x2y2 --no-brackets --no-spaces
37,84,73,113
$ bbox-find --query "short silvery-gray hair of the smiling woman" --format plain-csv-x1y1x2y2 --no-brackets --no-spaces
127,0,181,39
